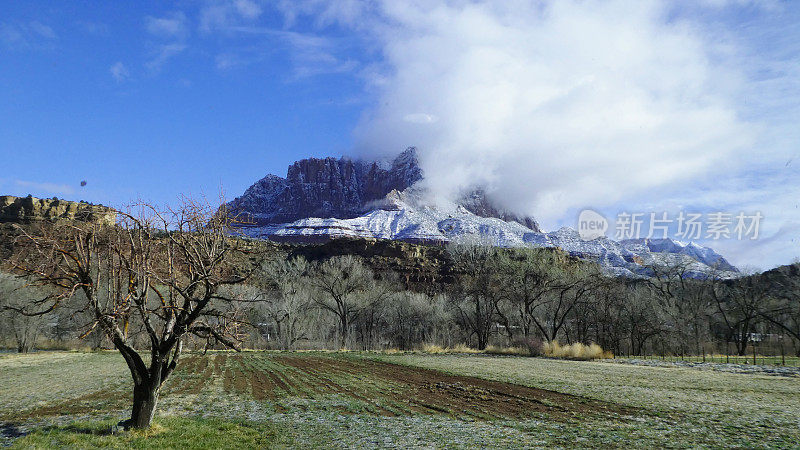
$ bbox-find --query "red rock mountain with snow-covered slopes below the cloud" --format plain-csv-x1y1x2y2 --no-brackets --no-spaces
226,147,738,277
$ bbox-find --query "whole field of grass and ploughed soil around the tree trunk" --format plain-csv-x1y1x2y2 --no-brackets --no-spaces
0,352,800,448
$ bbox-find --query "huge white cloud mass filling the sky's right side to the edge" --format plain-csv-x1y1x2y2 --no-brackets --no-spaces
279,0,800,264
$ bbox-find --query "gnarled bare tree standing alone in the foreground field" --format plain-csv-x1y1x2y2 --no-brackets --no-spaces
10,199,247,428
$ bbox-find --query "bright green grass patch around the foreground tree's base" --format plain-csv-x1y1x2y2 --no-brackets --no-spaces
12,417,293,449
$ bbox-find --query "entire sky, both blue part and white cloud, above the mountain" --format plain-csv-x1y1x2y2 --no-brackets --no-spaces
0,0,800,267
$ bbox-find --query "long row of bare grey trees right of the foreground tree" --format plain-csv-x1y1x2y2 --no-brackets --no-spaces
241,245,800,355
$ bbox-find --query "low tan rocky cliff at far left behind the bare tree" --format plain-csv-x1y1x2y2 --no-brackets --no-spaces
0,195,116,224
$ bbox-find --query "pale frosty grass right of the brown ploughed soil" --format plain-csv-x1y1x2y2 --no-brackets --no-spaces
380,354,800,447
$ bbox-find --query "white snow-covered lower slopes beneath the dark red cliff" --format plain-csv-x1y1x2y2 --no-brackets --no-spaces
242,187,737,276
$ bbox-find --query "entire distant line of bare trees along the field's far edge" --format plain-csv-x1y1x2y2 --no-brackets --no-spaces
0,236,800,355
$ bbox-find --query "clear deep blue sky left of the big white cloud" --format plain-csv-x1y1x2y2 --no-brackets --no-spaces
0,1,364,205
